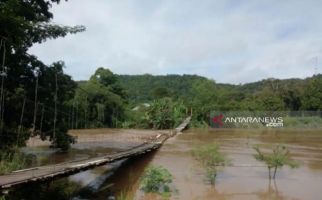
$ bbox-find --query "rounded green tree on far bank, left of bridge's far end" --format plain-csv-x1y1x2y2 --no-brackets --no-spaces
70,67,126,127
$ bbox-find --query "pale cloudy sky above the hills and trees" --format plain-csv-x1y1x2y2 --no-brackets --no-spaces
29,0,322,84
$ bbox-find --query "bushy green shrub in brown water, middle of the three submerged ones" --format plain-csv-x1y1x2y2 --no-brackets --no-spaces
192,143,227,185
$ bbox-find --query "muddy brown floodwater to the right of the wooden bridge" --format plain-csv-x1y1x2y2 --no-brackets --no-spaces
15,129,322,200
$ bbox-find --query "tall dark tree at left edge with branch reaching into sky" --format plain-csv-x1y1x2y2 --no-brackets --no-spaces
0,0,85,148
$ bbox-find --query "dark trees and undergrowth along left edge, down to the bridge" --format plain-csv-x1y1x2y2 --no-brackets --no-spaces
0,0,85,173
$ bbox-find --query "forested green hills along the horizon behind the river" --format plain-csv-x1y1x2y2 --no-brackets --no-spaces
118,74,322,111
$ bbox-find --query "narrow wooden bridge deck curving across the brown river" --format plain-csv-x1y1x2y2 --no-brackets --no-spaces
0,117,190,190
